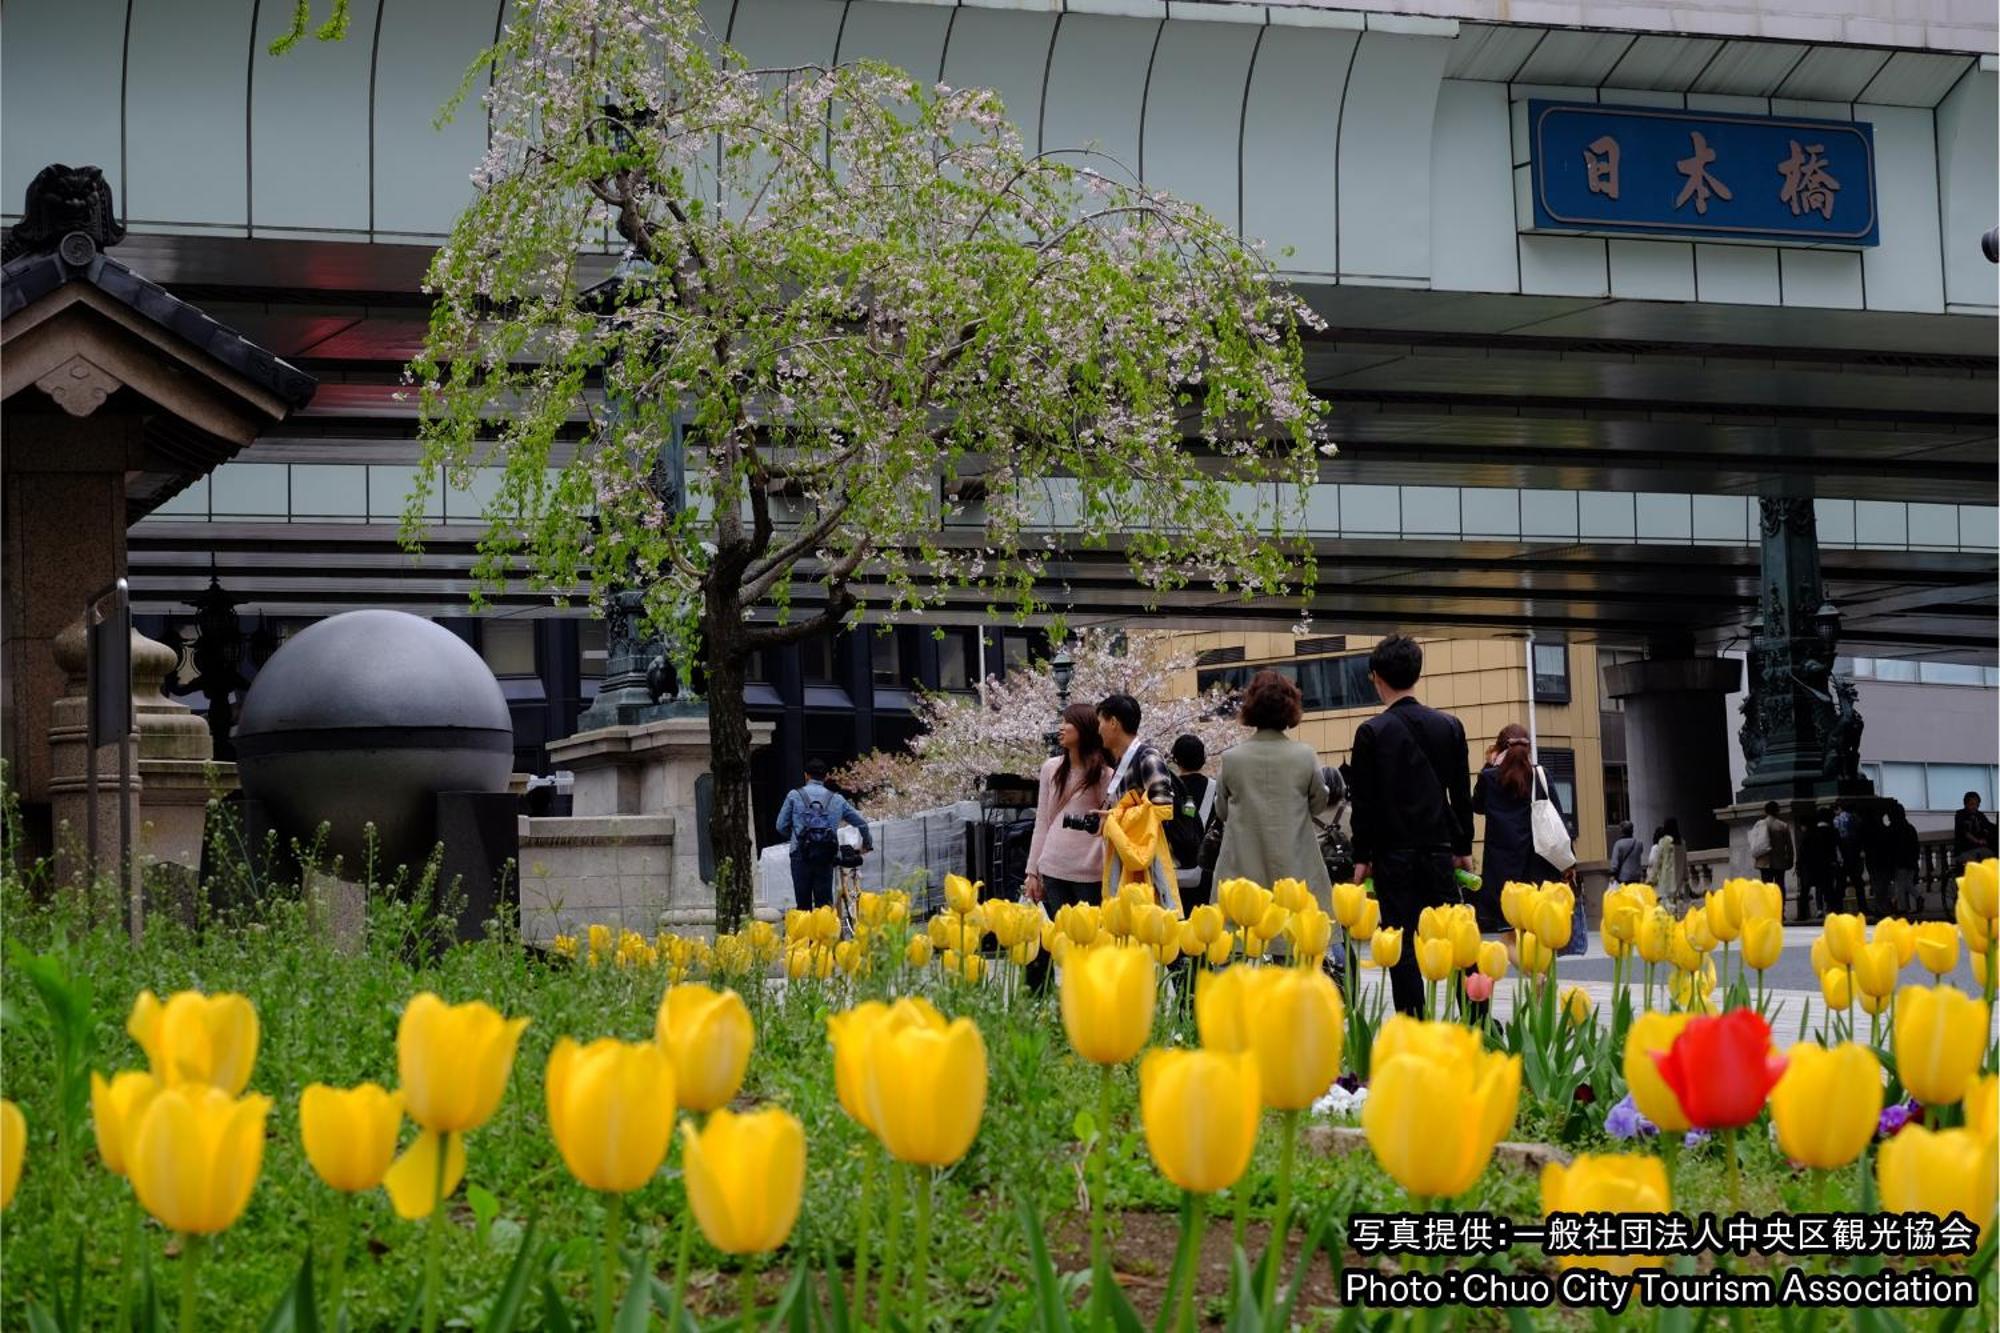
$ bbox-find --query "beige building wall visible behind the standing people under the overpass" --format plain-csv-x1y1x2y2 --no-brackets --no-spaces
1182,632,1606,861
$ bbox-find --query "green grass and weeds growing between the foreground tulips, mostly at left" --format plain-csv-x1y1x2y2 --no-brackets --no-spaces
0,879,1992,1329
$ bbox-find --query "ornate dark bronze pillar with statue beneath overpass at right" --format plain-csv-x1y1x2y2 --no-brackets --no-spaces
1738,496,1874,803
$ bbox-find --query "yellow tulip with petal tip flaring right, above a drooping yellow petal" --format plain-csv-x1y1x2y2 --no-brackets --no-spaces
396,991,528,1133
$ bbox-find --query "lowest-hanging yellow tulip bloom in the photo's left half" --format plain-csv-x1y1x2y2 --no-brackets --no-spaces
680,1107,806,1255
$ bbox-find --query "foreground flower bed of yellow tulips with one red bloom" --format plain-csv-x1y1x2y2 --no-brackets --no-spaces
0,863,2000,1333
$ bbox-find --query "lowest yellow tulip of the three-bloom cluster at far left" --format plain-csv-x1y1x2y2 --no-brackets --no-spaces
126,1083,270,1235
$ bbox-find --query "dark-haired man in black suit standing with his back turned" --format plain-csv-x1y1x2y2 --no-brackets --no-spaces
1348,634,1472,1015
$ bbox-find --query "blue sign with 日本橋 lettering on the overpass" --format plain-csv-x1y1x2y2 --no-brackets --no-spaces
1528,100,1880,246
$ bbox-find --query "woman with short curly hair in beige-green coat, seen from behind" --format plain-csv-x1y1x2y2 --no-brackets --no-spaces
1214,671,1334,913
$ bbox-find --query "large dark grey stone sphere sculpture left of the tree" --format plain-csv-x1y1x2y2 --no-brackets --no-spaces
236,610,514,879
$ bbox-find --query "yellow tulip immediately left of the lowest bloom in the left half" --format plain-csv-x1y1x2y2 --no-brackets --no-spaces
548,1037,674,1195
